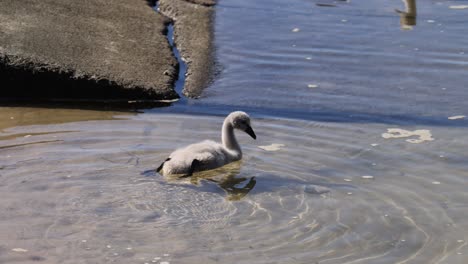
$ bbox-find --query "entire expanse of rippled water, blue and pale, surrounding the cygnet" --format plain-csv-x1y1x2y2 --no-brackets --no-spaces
0,0,468,264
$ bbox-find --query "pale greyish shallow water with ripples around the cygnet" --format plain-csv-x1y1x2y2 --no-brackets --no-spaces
0,113,468,263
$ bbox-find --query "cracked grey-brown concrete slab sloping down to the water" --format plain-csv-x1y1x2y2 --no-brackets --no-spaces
0,0,214,101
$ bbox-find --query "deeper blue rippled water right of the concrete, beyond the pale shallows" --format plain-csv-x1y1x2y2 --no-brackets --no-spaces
194,0,468,119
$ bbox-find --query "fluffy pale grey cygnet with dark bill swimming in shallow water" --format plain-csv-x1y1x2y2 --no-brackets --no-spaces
157,111,256,177
